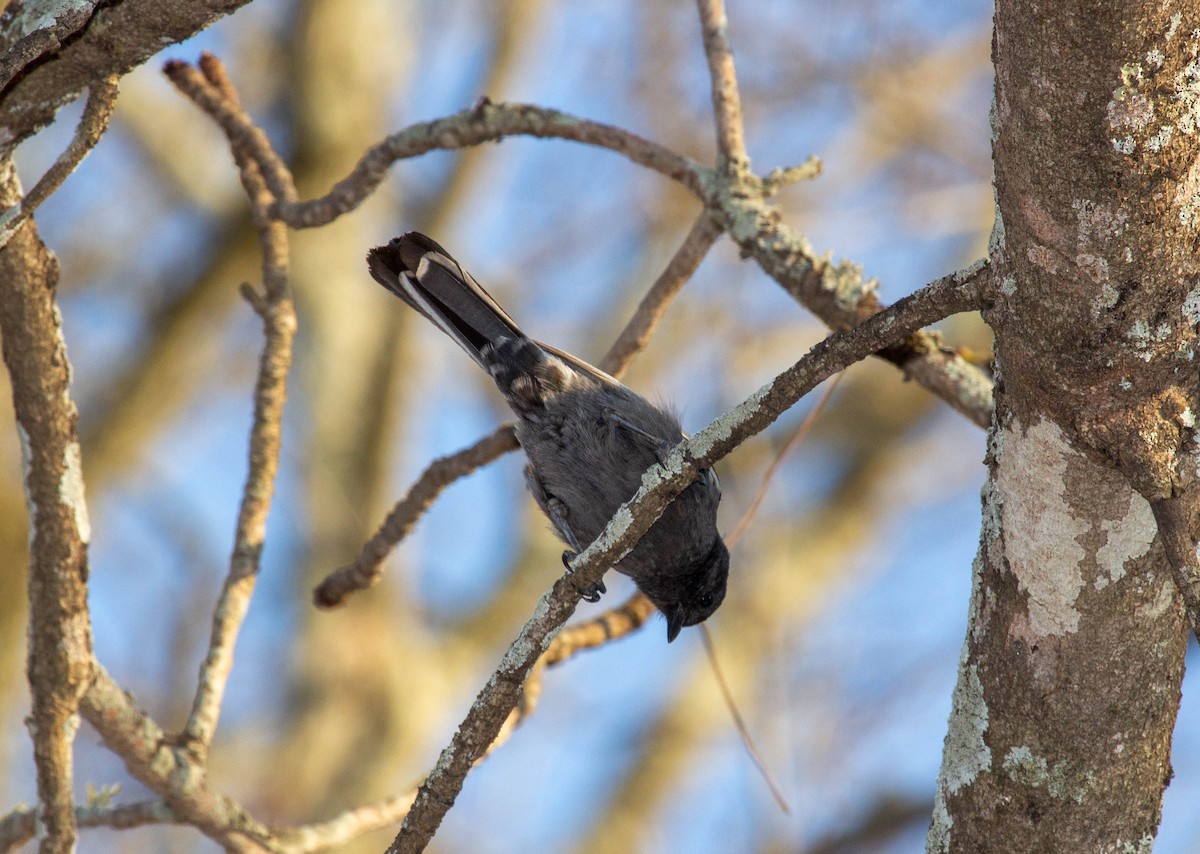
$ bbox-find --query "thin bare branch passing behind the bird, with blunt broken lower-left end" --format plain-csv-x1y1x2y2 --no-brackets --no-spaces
312,214,720,608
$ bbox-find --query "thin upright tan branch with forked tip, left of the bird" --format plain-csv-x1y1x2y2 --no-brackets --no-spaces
167,54,296,760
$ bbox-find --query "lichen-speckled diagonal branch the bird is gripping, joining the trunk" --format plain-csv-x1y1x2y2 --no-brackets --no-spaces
389,256,984,853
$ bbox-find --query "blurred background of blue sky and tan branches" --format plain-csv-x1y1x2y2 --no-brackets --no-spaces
0,0,1200,854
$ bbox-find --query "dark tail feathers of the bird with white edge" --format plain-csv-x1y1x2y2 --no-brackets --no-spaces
367,231,535,371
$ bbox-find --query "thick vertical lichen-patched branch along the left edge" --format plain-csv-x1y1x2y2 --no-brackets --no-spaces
0,158,95,852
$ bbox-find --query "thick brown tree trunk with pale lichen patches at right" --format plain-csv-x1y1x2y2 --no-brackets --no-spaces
929,0,1200,852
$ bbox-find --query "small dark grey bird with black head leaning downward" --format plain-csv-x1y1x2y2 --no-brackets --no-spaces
367,231,730,643
